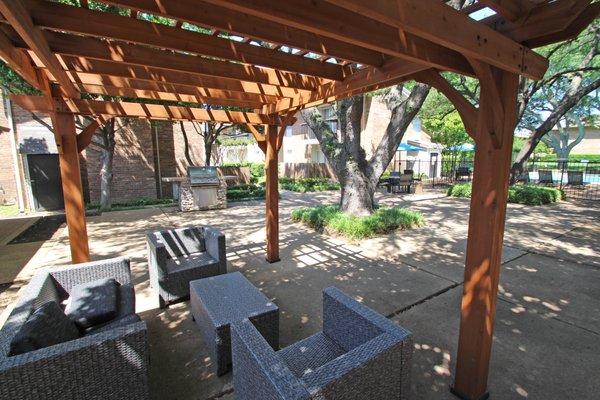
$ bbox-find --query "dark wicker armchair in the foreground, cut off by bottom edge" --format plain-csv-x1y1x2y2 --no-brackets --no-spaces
231,288,413,400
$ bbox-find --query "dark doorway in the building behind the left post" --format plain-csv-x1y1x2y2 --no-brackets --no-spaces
27,154,64,211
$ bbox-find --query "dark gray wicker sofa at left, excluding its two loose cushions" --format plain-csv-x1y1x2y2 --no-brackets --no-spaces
0,258,149,400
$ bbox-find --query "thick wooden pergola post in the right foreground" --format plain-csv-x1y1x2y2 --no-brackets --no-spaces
452,64,518,400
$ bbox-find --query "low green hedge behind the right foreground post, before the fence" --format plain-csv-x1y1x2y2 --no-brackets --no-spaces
447,183,564,206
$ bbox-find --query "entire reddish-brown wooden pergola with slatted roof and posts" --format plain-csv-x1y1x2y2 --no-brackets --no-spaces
0,0,600,399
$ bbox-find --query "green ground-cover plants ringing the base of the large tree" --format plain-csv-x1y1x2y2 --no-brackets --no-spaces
292,205,424,240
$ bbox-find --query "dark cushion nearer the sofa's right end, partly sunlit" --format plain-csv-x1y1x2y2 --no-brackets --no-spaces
65,278,118,329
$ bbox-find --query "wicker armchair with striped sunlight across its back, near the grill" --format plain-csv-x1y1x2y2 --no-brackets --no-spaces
146,226,227,308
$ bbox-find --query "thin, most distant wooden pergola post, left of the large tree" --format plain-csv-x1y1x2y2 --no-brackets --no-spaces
265,125,278,263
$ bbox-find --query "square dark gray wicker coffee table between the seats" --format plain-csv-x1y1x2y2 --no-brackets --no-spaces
190,272,279,375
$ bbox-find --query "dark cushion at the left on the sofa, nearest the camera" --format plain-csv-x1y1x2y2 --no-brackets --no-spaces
10,301,79,356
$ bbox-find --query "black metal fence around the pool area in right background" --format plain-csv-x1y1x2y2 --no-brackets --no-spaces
393,160,600,200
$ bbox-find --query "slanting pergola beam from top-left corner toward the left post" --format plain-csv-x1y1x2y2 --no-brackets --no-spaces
0,0,79,97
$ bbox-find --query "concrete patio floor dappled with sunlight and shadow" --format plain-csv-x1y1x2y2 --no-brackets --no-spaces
0,192,600,400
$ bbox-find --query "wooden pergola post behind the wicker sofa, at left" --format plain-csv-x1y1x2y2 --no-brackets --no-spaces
52,112,90,263
